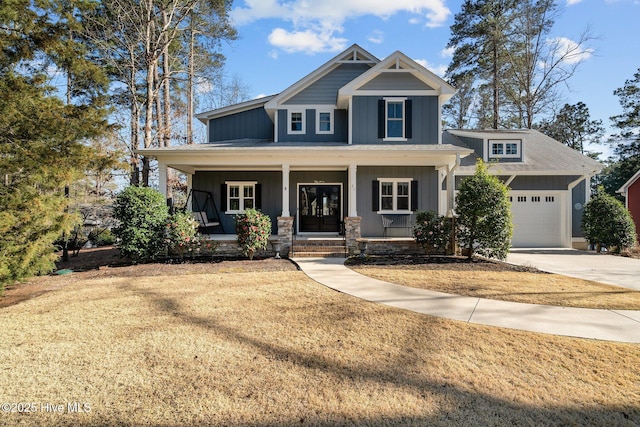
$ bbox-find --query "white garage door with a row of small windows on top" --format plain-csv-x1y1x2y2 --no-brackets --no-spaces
511,192,563,248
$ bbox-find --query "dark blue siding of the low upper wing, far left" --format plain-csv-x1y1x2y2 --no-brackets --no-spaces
209,106,273,142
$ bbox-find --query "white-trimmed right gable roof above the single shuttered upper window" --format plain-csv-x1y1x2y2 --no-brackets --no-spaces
338,51,456,108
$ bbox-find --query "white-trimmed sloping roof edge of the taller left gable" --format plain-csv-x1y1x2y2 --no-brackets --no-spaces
265,44,380,117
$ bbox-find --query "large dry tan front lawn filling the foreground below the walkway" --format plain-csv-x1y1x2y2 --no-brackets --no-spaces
0,269,640,426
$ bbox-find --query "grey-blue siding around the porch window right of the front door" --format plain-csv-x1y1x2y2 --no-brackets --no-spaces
357,166,438,237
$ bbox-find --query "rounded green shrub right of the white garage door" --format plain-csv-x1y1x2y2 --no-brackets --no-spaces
582,187,636,252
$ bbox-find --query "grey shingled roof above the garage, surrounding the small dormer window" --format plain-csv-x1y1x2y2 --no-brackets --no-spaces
442,129,603,175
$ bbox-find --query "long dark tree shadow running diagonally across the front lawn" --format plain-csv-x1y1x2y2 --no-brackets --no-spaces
115,286,640,427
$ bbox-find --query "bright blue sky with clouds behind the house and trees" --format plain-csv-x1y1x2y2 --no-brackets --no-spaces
215,0,640,144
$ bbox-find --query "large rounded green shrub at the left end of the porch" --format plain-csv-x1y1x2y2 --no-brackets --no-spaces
113,186,169,261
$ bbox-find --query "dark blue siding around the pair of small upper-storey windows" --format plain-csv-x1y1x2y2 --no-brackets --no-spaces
278,109,348,143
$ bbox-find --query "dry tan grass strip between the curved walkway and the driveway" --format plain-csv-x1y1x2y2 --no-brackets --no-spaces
351,263,640,310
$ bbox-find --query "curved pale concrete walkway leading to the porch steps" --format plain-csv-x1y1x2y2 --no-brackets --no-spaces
294,258,640,343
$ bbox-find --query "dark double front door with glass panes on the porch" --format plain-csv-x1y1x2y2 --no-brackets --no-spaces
298,184,341,233
